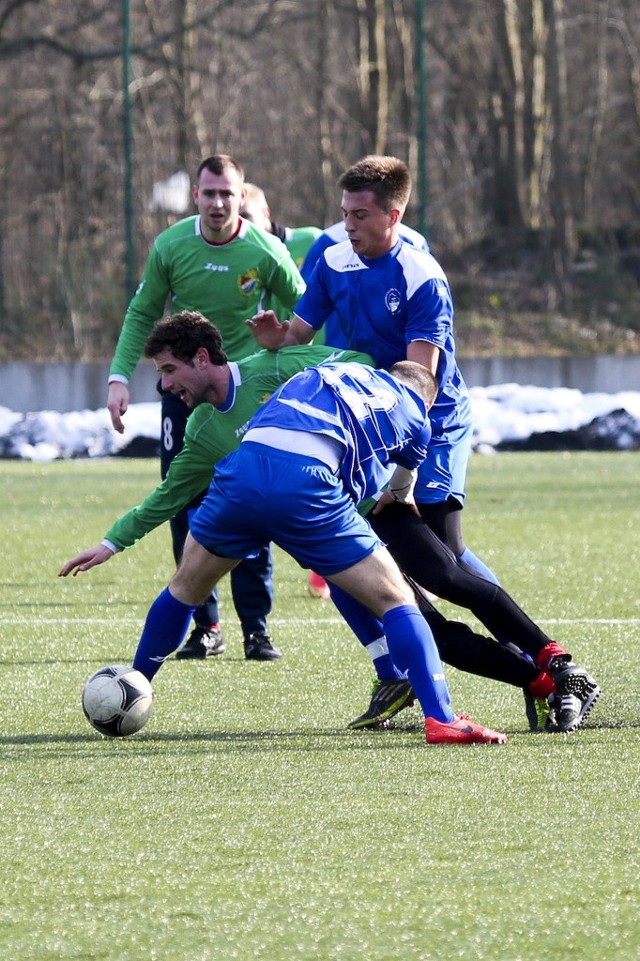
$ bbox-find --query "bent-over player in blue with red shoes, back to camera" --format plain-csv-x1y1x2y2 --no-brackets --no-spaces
134,362,506,744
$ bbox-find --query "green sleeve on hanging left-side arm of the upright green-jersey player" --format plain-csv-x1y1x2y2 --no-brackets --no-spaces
109,244,171,377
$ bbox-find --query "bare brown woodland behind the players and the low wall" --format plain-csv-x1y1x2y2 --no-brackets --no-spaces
0,0,640,361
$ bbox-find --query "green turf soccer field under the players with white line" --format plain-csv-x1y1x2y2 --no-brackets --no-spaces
0,453,640,961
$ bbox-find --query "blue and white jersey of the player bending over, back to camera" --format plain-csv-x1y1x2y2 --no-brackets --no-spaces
247,363,431,503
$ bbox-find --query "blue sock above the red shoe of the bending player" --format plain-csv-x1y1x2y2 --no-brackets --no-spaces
382,604,455,722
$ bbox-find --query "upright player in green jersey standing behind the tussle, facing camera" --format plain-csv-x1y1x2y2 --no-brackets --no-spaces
107,154,304,660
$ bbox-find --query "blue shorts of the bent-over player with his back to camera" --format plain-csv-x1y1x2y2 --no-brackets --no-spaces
190,441,381,576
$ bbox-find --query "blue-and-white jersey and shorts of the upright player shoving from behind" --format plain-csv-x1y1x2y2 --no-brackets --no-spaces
295,239,473,502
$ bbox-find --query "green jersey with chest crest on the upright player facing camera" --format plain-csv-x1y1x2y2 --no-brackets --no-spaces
110,216,304,378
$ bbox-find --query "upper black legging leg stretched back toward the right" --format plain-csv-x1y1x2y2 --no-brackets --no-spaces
367,504,551,659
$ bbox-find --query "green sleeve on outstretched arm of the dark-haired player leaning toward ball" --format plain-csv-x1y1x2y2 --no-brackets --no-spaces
105,420,217,550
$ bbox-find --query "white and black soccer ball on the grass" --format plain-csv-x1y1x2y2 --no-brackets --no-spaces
82,664,153,737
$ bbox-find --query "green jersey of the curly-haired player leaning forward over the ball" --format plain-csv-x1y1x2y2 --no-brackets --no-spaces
105,346,372,550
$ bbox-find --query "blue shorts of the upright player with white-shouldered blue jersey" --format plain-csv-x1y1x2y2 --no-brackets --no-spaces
414,424,473,504
